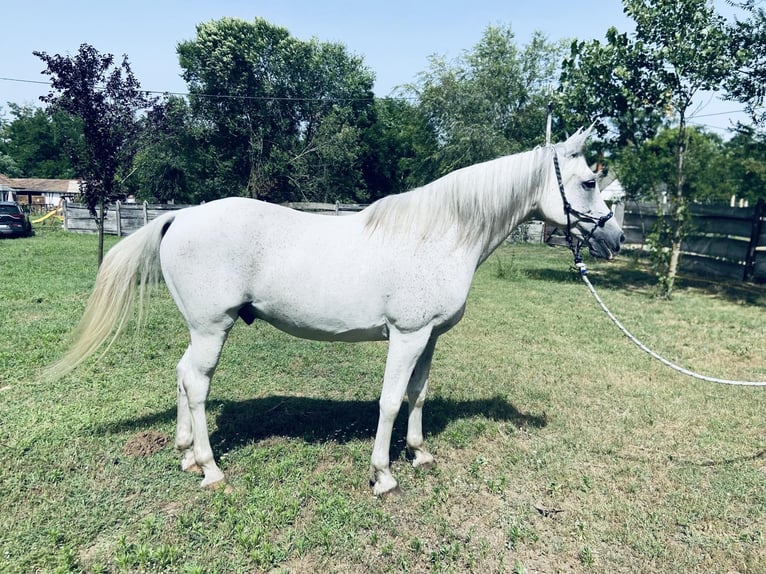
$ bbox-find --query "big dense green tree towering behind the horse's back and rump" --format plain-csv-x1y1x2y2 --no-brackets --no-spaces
178,18,374,205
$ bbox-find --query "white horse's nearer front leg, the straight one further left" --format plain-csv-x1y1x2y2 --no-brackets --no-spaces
370,327,431,496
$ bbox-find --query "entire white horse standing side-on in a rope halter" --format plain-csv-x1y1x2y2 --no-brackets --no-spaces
51,131,623,495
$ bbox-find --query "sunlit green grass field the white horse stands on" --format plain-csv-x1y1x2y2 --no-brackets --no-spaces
0,230,766,574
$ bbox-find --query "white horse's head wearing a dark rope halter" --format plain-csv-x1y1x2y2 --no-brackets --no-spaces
538,129,625,259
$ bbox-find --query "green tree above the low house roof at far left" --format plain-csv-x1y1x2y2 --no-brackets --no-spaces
0,103,82,179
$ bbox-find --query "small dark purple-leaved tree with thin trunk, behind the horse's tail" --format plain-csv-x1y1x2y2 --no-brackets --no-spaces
34,44,154,265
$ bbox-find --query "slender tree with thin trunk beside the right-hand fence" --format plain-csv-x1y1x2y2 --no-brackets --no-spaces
561,0,736,298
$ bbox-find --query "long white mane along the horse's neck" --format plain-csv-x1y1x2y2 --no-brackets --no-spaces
365,148,551,248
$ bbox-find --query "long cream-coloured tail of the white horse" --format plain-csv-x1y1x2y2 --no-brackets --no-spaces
44,212,176,379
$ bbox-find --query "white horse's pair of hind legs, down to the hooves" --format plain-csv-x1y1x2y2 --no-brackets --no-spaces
176,330,228,487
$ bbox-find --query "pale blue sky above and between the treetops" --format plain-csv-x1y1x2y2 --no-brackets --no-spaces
0,0,756,134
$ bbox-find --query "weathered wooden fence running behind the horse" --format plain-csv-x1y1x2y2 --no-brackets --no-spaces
64,200,766,283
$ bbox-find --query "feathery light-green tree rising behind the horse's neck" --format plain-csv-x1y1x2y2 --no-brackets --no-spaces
405,26,563,179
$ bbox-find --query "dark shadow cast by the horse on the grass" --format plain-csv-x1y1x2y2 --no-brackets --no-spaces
102,395,547,456
